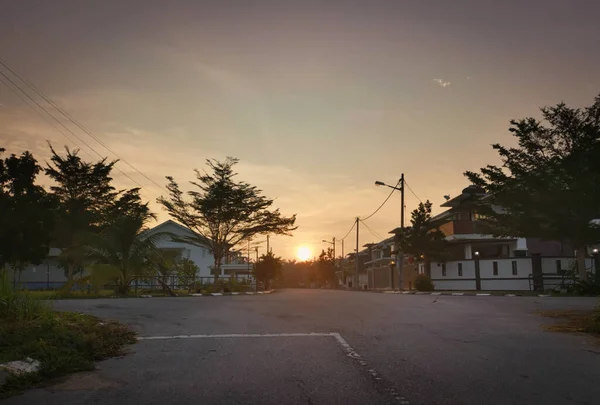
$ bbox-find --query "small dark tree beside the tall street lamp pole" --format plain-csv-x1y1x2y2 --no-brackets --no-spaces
395,200,448,260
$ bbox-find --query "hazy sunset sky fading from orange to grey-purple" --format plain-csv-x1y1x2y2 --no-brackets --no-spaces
0,0,600,258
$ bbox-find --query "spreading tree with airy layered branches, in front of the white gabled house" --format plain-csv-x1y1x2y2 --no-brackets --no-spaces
157,158,297,282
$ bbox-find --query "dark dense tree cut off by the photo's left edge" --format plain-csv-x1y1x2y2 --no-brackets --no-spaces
0,148,56,273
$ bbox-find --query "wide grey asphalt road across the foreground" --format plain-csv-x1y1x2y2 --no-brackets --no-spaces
5,289,600,405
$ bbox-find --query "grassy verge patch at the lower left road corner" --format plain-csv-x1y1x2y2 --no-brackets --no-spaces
0,311,136,398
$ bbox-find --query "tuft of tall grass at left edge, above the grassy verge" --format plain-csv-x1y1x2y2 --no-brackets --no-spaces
0,274,50,322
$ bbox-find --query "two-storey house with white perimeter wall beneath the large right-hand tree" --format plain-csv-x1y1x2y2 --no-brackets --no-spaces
428,186,592,290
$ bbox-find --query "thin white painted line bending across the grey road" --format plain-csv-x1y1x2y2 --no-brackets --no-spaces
137,332,410,405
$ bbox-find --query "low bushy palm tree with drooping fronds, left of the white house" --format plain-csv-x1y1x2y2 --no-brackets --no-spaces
83,189,159,294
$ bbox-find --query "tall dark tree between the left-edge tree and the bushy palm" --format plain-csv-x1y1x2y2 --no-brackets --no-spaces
45,146,118,288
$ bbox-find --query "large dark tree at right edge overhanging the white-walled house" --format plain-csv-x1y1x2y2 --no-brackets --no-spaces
465,95,600,280
